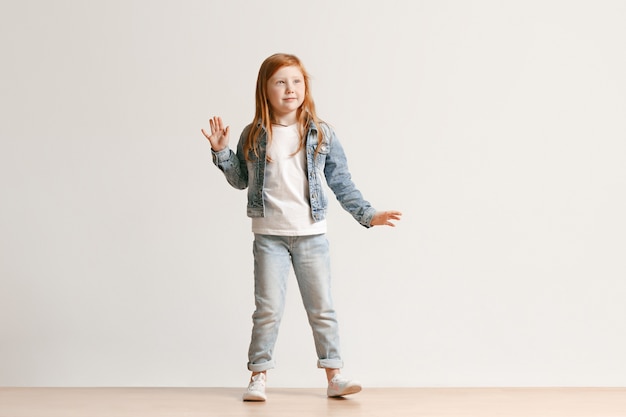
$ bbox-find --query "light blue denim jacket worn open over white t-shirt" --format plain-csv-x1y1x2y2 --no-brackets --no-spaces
211,123,376,227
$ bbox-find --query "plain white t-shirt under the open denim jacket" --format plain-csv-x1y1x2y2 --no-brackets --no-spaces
252,124,326,236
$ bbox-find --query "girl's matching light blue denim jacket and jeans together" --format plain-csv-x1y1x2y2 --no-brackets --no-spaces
212,123,376,372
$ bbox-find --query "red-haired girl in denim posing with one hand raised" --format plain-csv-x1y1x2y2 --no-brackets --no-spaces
202,54,401,401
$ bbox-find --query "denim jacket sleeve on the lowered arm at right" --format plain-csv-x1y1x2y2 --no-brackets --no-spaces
324,129,376,227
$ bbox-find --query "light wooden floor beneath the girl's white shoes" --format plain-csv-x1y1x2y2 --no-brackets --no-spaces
0,388,626,417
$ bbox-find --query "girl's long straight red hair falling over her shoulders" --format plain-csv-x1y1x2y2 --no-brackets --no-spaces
243,54,324,160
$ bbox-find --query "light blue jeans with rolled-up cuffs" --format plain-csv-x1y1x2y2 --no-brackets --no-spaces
248,234,343,372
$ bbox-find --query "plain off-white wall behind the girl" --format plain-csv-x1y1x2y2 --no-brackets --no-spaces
0,0,626,387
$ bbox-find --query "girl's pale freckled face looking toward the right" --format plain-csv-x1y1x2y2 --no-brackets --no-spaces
267,66,306,123
